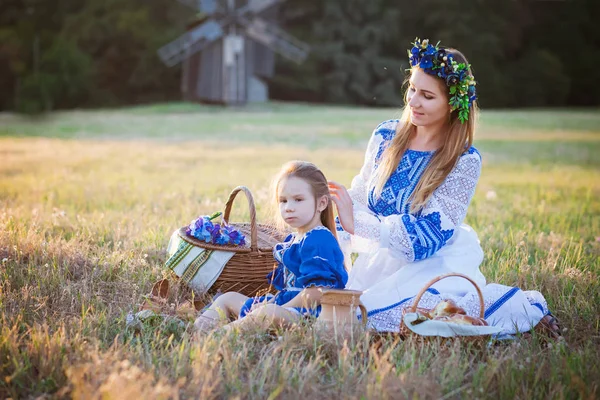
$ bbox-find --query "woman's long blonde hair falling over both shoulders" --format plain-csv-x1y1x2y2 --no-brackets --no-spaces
375,48,479,213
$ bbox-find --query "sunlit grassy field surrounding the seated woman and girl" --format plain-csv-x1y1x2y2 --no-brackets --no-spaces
0,103,600,399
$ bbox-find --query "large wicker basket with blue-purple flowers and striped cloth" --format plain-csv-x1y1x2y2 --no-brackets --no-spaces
166,186,284,296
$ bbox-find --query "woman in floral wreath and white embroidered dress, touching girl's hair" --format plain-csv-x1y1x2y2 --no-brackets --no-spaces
329,39,559,334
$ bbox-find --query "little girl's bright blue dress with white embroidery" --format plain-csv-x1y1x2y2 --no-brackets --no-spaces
240,226,348,318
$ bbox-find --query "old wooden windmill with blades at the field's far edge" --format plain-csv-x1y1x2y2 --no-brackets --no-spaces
158,0,309,104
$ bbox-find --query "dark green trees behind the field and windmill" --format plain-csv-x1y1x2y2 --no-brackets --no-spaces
0,0,600,113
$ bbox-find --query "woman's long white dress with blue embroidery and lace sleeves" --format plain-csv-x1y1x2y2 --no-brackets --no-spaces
338,120,548,334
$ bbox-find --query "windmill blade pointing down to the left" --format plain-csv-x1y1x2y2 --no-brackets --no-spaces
158,20,223,67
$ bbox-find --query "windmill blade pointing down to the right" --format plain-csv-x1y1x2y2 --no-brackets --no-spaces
238,16,310,63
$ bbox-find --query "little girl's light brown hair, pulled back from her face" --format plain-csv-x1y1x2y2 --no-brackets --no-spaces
271,161,337,238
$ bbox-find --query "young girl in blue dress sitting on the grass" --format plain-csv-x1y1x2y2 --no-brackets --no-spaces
194,161,348,330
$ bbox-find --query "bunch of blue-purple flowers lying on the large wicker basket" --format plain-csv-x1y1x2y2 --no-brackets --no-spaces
185,212,246,246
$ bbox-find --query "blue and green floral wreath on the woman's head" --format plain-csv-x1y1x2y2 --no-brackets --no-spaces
408,38,477,123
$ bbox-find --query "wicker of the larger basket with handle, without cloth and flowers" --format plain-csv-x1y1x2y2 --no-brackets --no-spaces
179,186,285,296
